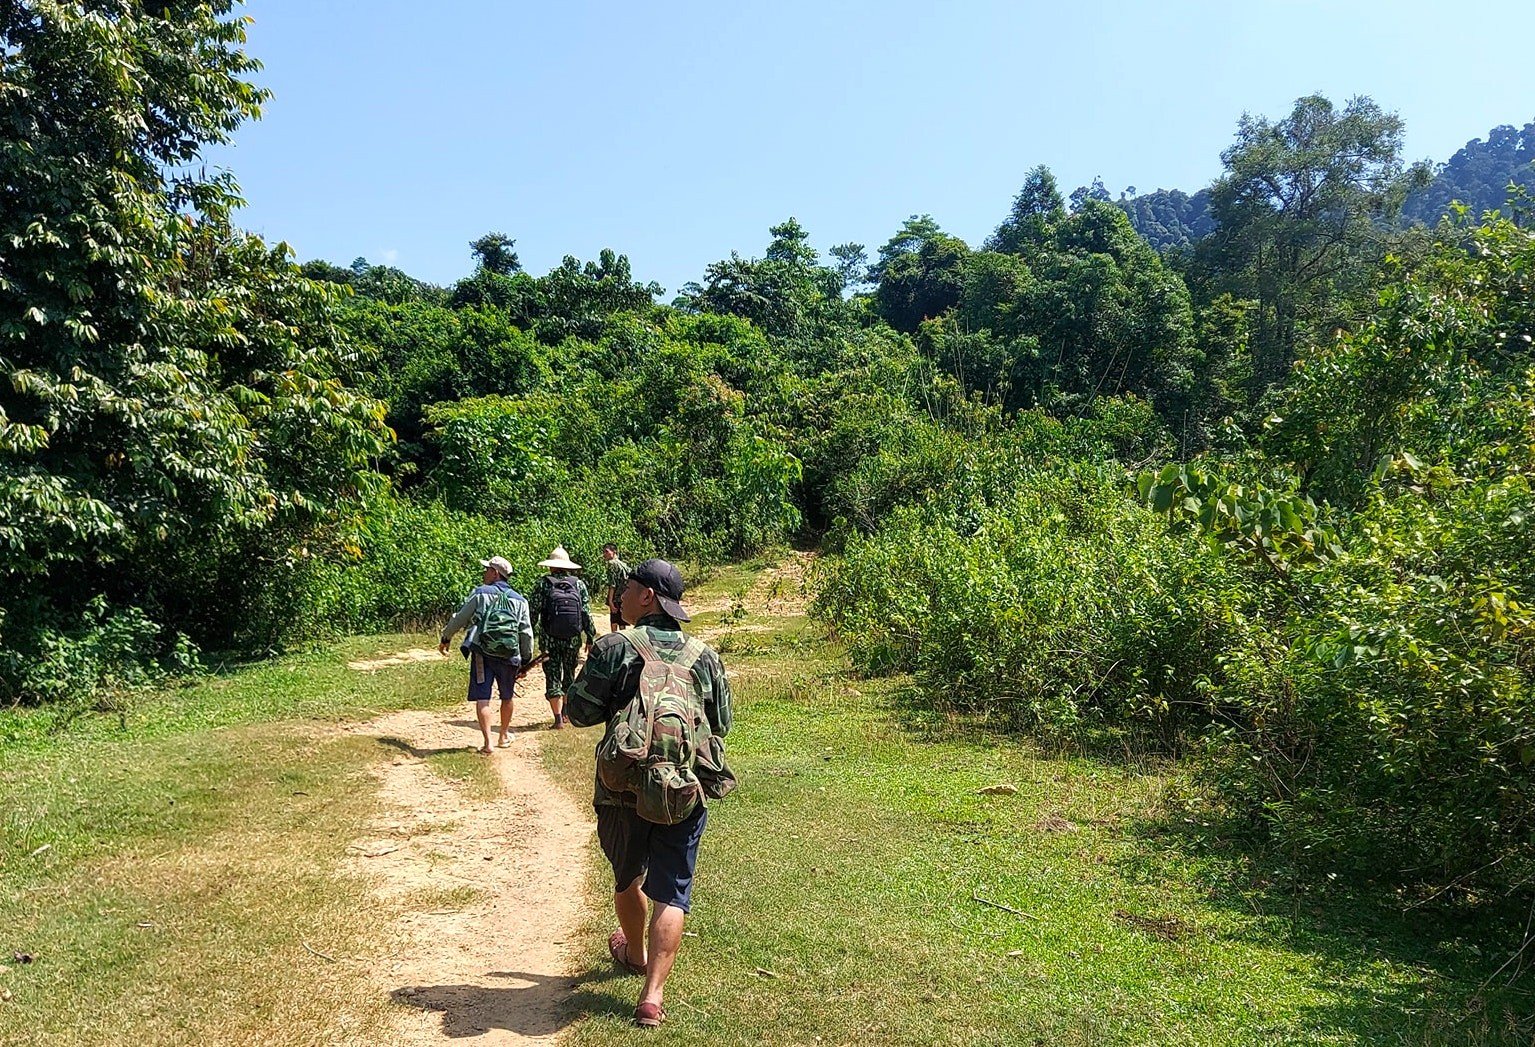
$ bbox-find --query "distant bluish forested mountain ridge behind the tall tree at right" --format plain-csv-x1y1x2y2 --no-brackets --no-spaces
1114,121,1535,252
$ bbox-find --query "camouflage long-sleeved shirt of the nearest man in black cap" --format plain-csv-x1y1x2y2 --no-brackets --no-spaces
565,614,731,808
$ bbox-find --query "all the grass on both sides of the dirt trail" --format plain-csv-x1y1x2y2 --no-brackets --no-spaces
0,568,1535,1045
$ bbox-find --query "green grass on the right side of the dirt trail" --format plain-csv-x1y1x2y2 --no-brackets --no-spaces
546,579,1532,1045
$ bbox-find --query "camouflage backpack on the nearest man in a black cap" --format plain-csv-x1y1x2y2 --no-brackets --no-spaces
597,628,734,826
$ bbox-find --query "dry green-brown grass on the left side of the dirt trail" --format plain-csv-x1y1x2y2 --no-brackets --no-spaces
0,637,482,1044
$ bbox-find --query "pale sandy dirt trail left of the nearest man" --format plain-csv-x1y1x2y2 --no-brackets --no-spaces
352,651,593,1044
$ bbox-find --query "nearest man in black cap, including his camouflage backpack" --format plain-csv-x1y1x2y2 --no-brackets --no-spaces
569,560,735,1027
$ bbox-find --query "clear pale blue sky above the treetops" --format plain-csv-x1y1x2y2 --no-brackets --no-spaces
210,0,1535,298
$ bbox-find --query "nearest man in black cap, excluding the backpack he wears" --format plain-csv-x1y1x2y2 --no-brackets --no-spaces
569,560,731,1027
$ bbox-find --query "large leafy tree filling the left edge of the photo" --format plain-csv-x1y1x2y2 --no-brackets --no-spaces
0,0,384,672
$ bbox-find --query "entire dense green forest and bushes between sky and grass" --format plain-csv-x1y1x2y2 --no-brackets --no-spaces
0,0,1535,893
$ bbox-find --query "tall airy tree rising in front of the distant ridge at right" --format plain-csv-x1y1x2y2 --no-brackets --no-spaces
1208,95,1426,385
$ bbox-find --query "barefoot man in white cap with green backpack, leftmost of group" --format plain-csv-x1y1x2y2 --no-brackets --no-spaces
437,556,533,755
